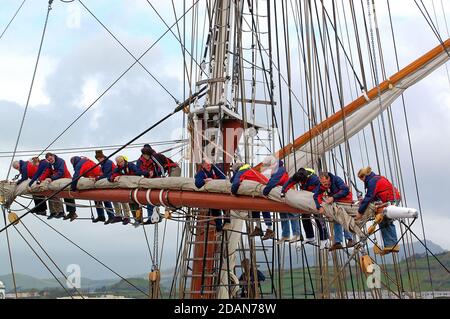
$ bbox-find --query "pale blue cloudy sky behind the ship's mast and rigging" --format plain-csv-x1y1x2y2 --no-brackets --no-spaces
0,0,450,279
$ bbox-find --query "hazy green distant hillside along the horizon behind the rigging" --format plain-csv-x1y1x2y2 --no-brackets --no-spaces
0,241,450,298
